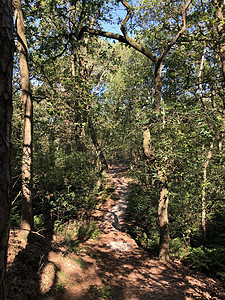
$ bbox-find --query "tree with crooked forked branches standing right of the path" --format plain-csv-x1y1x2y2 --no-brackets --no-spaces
75,0,191,260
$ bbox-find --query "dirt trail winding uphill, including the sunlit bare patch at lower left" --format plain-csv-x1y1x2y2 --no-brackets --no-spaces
7,166,225,300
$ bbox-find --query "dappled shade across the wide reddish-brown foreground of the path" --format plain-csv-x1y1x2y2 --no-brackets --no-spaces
77,243,225,300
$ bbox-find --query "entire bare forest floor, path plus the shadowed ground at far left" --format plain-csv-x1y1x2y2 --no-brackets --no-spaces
7,166,225,300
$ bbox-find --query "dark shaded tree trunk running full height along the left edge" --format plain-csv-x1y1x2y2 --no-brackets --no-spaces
0,0,14,300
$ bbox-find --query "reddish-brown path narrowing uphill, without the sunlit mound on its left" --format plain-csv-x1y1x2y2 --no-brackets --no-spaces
62,167,225,300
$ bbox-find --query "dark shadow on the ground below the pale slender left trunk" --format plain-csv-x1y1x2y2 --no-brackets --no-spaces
7,231,63,300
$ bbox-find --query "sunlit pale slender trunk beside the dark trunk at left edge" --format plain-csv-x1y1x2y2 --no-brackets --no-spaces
14,0,33,233
